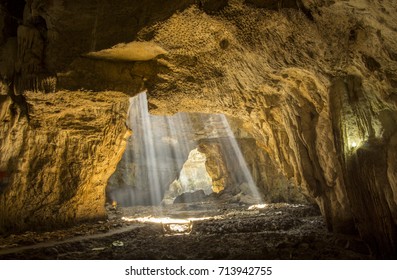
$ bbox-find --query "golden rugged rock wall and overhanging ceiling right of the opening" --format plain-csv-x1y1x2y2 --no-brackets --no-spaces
135,1,397,256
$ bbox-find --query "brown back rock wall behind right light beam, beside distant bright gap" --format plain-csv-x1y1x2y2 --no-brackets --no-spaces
198,137,309,203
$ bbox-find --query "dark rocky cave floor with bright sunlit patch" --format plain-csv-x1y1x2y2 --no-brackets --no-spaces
0,202,372,260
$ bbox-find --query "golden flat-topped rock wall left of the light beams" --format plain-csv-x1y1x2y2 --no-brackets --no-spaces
0,92,128,232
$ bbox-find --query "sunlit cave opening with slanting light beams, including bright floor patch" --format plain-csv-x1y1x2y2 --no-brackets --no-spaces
106,92,308,234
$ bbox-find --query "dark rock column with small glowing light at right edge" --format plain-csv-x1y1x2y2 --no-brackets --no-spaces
330,73,397,252
